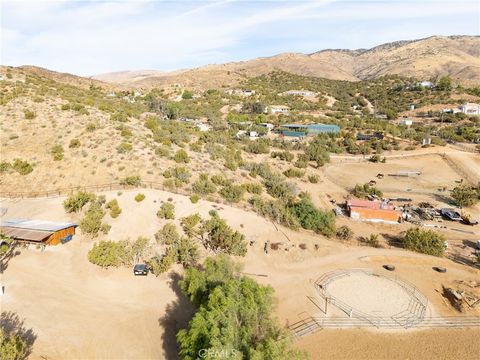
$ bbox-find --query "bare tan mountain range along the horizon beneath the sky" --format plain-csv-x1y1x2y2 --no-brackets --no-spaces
94,36,480,88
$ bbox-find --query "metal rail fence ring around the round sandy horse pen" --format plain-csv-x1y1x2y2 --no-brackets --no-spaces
315,269,428,328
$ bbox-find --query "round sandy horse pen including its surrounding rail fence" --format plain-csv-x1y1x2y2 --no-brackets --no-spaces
315,269,428,328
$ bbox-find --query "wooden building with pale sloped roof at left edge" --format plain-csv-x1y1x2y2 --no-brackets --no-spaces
0,219,78,245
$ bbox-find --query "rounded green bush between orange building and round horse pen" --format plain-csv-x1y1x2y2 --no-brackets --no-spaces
402,228,446,256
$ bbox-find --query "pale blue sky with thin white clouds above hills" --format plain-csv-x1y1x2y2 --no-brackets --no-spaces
0,0,480,76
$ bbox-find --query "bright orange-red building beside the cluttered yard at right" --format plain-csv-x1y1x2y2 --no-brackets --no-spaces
345,199,401,224
